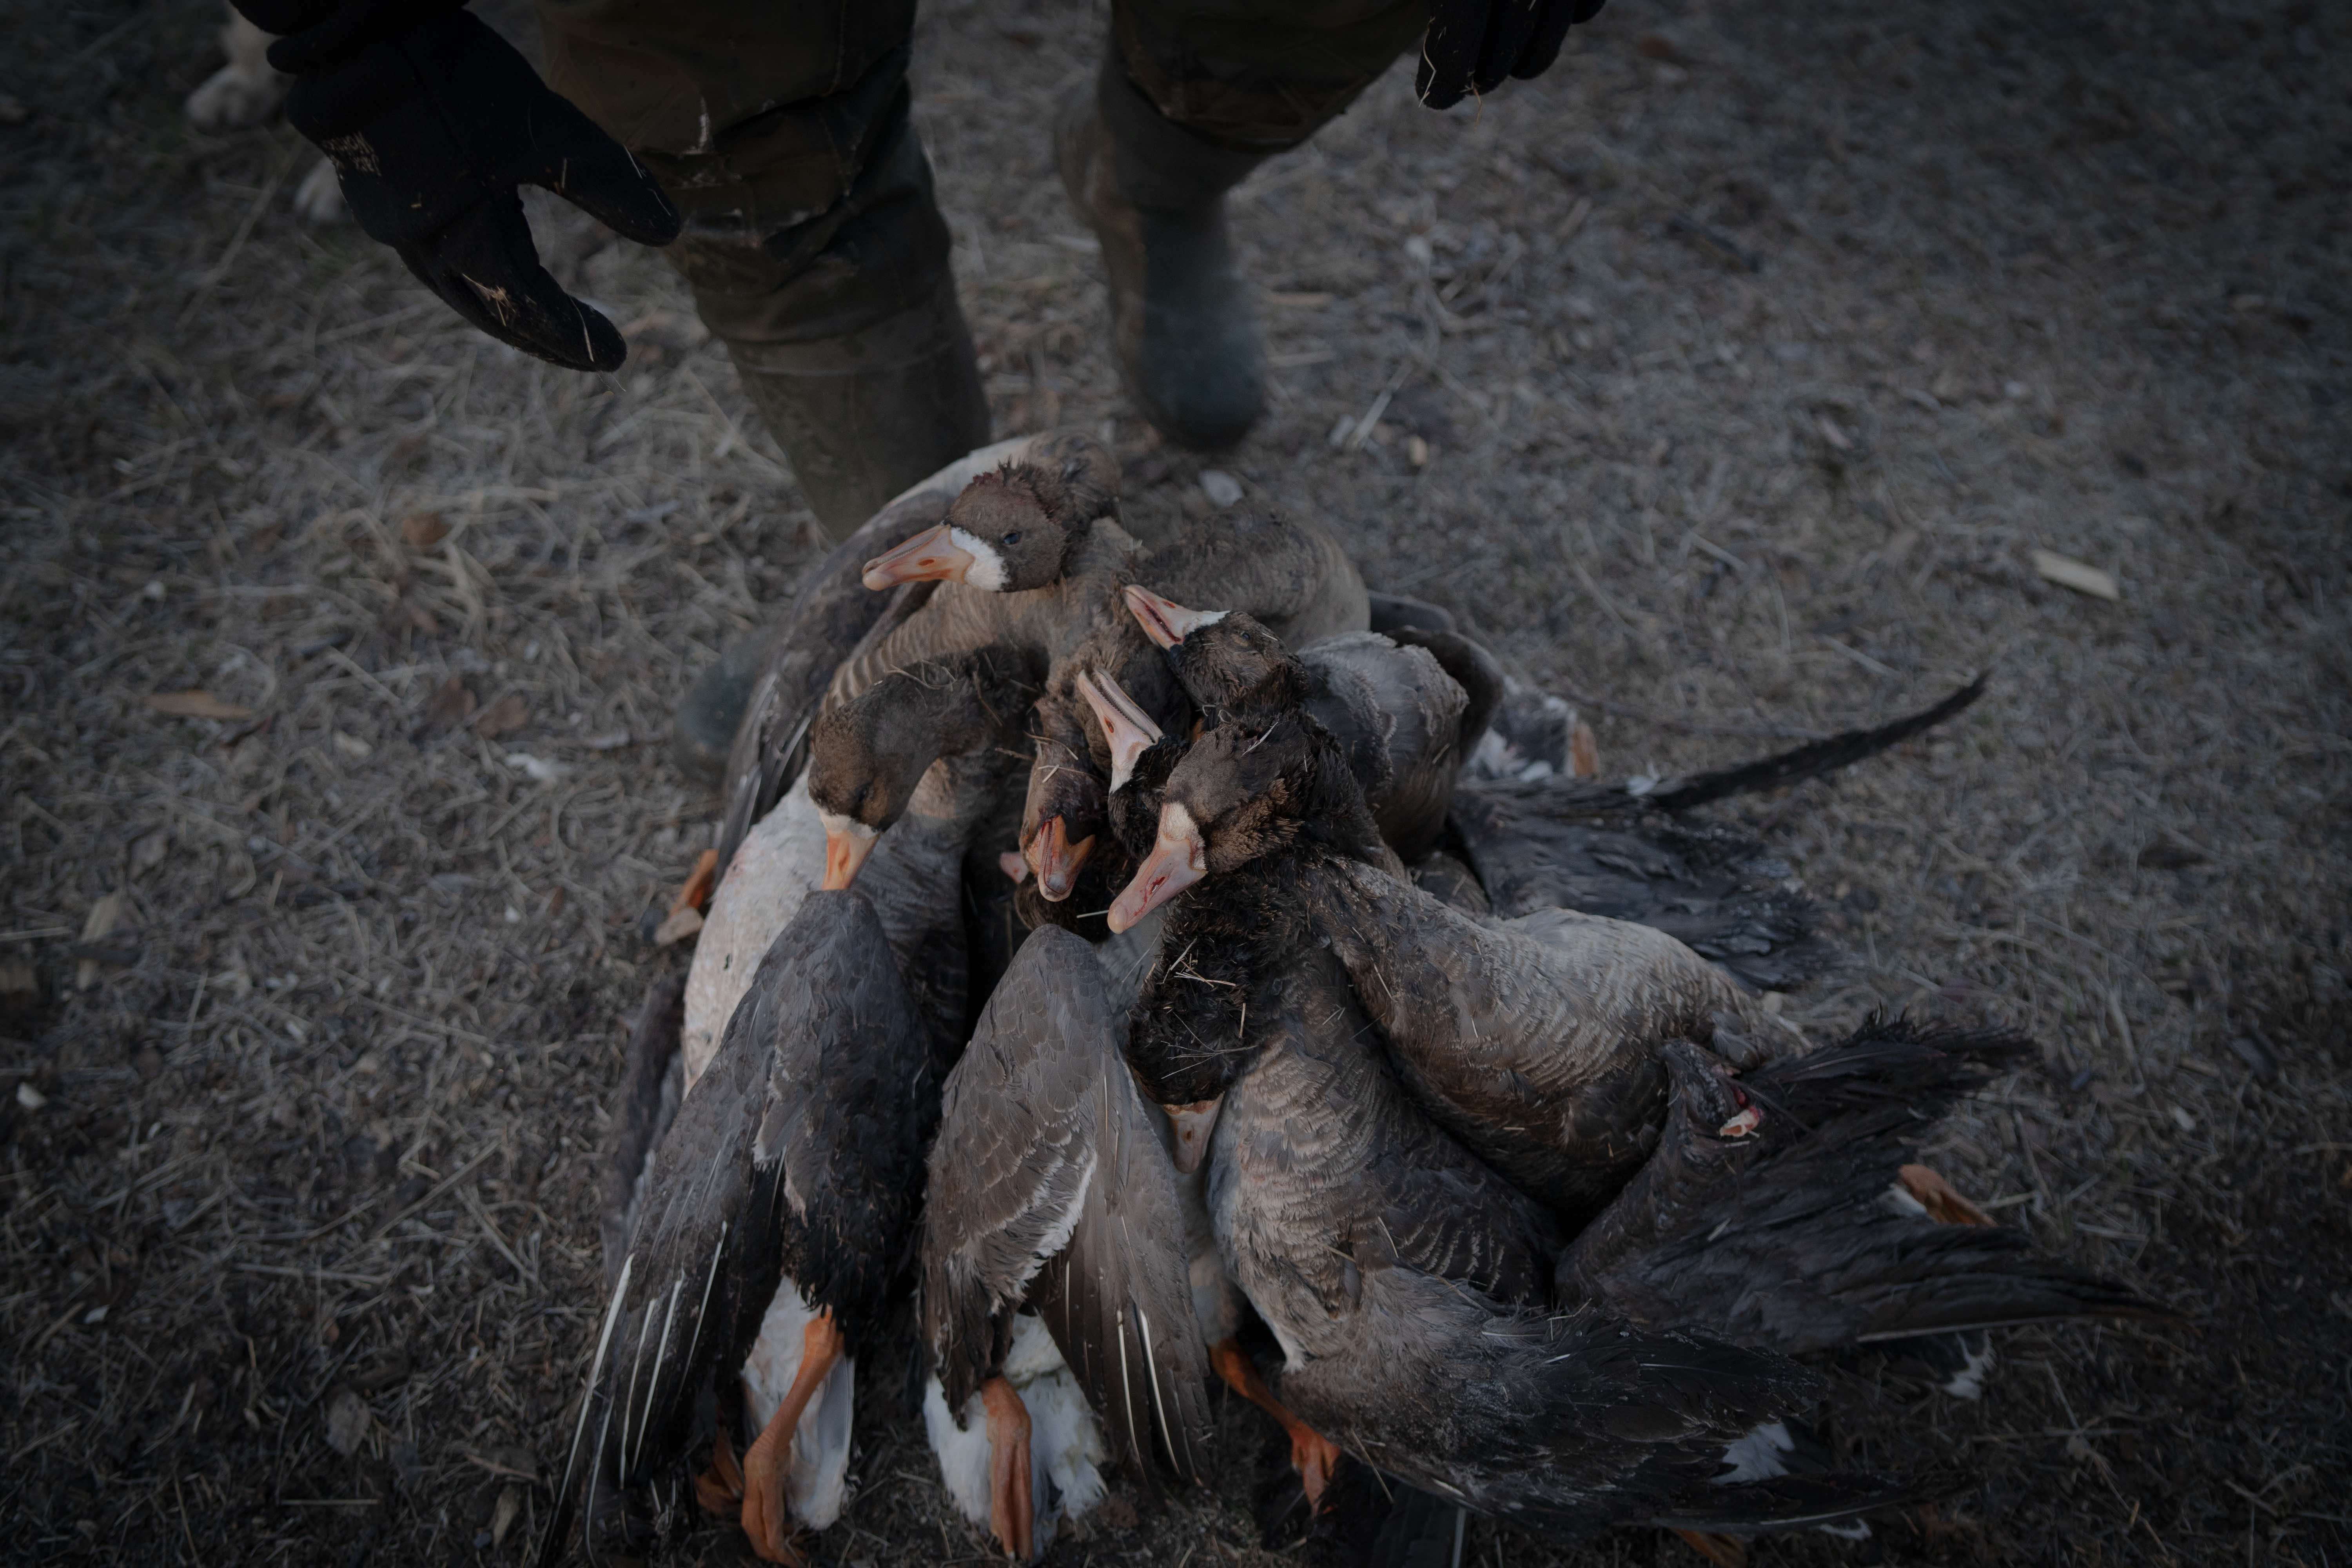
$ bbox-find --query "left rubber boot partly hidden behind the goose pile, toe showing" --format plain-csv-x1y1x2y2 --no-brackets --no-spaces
675,285,988,780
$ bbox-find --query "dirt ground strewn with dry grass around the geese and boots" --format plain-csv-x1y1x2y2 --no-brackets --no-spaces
0,0,2352,1568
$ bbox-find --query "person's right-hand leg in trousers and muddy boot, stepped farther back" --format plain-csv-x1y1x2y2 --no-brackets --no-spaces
1056,0,1430,449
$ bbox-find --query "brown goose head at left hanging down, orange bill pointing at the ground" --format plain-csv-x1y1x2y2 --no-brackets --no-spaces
809,646,1035,889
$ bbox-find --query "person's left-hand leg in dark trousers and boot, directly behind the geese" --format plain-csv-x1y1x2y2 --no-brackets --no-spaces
539,0,988,538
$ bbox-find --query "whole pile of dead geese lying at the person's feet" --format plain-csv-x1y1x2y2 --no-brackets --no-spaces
543,435,2150,1561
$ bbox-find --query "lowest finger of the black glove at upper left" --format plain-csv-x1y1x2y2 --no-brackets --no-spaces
397,193,628,372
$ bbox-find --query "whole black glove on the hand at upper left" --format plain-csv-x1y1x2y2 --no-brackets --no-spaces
240,0,677,372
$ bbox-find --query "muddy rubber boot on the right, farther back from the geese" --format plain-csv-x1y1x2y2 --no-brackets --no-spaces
1054,59,1265,451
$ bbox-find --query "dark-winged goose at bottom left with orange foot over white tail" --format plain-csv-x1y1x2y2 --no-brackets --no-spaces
543,891,938,1561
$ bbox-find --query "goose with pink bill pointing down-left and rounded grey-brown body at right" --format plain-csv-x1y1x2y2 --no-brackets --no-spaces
1110,708,1752,1220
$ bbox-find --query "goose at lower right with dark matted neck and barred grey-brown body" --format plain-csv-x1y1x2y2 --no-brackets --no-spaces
1110,832,1900,1533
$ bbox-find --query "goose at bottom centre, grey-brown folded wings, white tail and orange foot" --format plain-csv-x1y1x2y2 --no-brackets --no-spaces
922,929,1209,1561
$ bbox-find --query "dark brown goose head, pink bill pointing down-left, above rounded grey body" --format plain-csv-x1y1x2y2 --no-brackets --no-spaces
1110,708,1381,931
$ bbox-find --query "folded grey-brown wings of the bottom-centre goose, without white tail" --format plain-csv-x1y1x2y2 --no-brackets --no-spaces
922,926,1209,1479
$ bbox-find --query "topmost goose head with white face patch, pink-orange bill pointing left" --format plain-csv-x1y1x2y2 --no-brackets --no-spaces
866,458,1101,592
